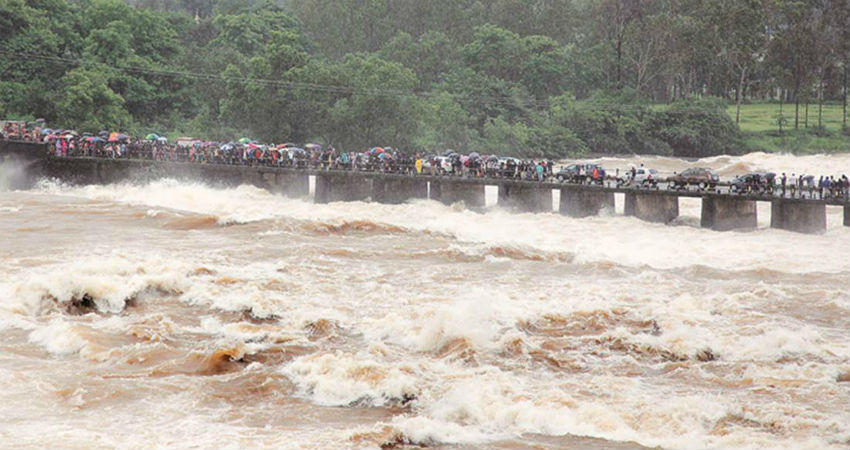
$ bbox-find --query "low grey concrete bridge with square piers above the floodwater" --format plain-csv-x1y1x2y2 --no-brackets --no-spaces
0,141,850,233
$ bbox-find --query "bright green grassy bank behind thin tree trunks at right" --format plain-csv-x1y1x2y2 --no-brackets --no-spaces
727,103,850,154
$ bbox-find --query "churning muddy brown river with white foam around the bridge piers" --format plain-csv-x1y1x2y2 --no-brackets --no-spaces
0,154,850,449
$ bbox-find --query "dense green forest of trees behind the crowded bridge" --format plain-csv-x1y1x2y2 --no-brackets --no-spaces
0,0,850,157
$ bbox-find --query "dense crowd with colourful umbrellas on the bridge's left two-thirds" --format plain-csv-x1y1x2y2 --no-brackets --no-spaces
4,123,554,182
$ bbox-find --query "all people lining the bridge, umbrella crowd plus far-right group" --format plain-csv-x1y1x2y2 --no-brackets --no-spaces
2,121,850,200
